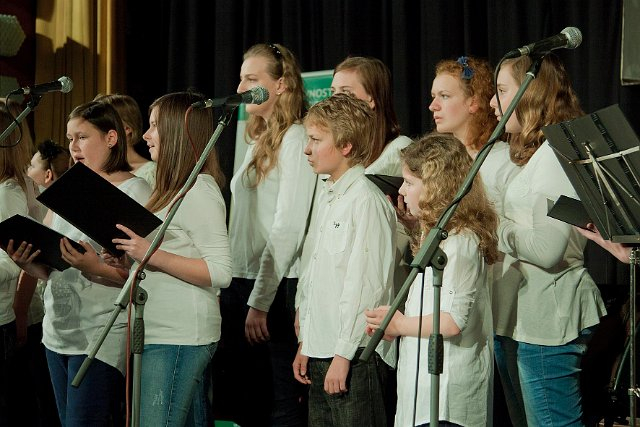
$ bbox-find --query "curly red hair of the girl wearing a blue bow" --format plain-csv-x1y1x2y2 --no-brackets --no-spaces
436,56,498,151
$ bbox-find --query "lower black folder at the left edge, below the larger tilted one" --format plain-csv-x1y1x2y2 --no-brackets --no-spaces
0,215,84,271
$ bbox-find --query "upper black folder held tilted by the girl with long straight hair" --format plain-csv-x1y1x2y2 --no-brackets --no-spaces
37,163,162,256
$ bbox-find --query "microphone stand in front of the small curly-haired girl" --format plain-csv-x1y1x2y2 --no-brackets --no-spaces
360,55,544,427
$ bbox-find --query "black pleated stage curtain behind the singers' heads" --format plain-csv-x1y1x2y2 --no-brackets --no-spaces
125,0,640,285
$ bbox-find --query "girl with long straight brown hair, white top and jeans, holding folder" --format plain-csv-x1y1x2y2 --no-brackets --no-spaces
113,92,231,427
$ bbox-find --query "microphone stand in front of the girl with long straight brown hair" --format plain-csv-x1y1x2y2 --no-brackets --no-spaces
71,106,236,427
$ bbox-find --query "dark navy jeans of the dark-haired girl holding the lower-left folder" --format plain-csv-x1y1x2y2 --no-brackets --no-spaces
46,349,125,427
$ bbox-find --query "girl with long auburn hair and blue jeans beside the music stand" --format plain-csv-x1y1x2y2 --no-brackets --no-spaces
491,54,606,425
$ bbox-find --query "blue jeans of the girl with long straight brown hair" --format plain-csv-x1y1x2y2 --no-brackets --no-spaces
140,343,218,427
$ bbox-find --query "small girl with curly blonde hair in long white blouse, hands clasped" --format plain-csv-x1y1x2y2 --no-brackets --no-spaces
365,134,497,427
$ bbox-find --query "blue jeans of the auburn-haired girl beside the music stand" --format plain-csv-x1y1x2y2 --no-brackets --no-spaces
496,328,594,426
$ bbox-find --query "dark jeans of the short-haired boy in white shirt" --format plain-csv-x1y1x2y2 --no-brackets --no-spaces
308,349,388,427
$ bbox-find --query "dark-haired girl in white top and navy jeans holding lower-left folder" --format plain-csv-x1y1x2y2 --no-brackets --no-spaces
8,102,151,427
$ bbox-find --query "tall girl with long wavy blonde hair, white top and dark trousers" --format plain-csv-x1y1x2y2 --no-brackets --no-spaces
214,43,316,425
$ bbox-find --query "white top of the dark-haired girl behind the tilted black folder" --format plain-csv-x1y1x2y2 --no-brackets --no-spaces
42,177,151,374
